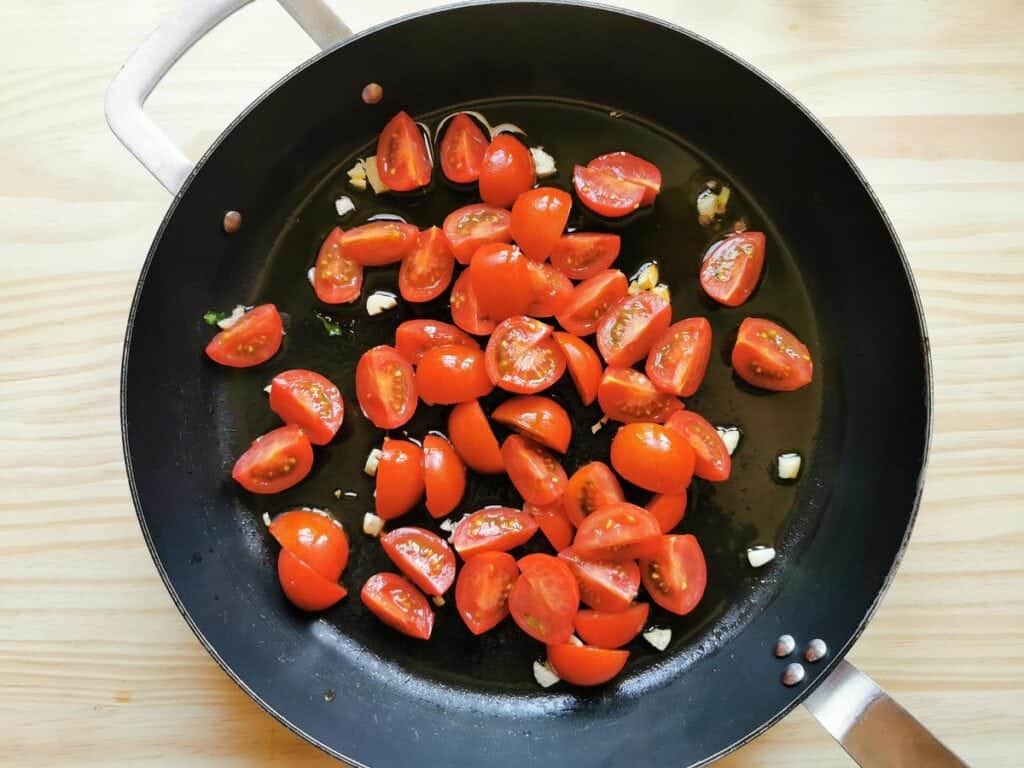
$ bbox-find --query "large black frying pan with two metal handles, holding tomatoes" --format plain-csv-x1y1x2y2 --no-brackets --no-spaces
106,0,963,768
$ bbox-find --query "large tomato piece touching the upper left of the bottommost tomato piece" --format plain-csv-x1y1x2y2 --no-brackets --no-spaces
509,554,580,644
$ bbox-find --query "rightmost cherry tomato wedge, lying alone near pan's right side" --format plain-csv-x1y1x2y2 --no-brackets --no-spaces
732,317,814,392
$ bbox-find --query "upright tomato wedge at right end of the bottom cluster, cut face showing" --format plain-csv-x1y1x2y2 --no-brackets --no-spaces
640,534,708,616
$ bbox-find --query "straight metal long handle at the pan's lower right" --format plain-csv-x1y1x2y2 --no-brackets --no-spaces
804,660,968,768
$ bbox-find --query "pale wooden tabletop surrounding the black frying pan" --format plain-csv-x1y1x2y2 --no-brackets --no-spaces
0,0,1024,768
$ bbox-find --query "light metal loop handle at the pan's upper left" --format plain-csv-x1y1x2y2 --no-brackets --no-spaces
104,0,352,195
